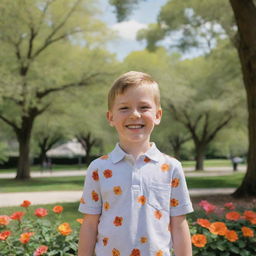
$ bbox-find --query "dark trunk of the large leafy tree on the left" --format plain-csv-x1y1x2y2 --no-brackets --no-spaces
16,117,34,180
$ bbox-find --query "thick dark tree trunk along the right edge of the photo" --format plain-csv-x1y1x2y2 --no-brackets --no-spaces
230,0,256,197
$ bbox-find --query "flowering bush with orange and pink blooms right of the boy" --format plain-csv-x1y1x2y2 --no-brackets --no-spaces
190,201,256,256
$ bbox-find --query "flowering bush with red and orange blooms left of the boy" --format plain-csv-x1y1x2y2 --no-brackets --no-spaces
0,200,82,256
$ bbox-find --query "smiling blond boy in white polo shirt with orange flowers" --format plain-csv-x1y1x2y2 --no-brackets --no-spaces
78,71,193,256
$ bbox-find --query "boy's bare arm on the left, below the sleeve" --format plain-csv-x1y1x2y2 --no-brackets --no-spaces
78,214,100,256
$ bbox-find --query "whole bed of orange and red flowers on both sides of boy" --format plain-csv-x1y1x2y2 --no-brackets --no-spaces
0,200,256,256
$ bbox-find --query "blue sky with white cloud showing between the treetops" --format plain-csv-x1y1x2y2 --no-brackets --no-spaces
100,0,167,60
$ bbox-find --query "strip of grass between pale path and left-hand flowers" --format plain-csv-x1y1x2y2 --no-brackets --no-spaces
0,202,83,225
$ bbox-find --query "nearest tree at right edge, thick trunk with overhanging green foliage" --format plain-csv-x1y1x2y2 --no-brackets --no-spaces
109,0,256,197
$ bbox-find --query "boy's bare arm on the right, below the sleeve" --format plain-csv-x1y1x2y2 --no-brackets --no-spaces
170,215,192,256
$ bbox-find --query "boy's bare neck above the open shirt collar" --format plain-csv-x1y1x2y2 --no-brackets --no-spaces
119,141,151,159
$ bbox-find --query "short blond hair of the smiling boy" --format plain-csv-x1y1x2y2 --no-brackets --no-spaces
108,71,161,110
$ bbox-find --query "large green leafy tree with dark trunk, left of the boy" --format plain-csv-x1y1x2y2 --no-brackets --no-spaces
0,0,111,179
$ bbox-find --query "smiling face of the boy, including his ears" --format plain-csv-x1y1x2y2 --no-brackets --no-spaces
107,85,162,146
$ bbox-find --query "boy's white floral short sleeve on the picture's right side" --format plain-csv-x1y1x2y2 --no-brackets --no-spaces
170,162,193,216
